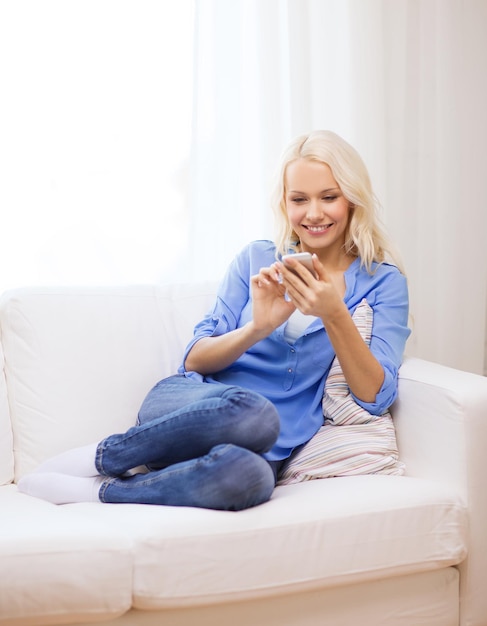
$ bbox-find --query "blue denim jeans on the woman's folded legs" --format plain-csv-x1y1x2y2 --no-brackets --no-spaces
96,375,279,510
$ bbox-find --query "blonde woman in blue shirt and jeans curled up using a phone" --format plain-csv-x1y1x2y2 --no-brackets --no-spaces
19,131,409,510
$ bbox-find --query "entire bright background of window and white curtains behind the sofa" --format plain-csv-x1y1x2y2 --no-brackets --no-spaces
0,0,487,372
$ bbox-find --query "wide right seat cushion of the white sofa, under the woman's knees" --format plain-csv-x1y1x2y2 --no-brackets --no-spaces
68,475,467,609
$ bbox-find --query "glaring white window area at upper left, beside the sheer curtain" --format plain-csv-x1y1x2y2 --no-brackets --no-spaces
0,0,193,289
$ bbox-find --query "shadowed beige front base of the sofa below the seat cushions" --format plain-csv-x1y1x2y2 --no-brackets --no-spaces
47,567,459,626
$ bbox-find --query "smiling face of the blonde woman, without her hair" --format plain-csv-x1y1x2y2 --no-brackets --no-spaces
284,159,350,257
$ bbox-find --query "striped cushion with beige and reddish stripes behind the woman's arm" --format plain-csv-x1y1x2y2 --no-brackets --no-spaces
278,299,404,485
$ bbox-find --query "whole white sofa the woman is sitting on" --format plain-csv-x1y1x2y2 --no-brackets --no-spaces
0,284,487,626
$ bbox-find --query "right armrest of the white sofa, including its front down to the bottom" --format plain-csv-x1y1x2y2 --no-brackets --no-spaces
392,358,487,625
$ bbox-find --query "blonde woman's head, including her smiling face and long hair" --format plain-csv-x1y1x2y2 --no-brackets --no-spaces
272,131,401,272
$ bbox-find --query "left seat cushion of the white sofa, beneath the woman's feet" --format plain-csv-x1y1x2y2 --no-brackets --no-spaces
0,485,133,626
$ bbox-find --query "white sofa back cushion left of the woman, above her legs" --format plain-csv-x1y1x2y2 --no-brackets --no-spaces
0,285,214,480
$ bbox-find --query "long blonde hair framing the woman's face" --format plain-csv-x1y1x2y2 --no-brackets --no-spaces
271,130,402,273
